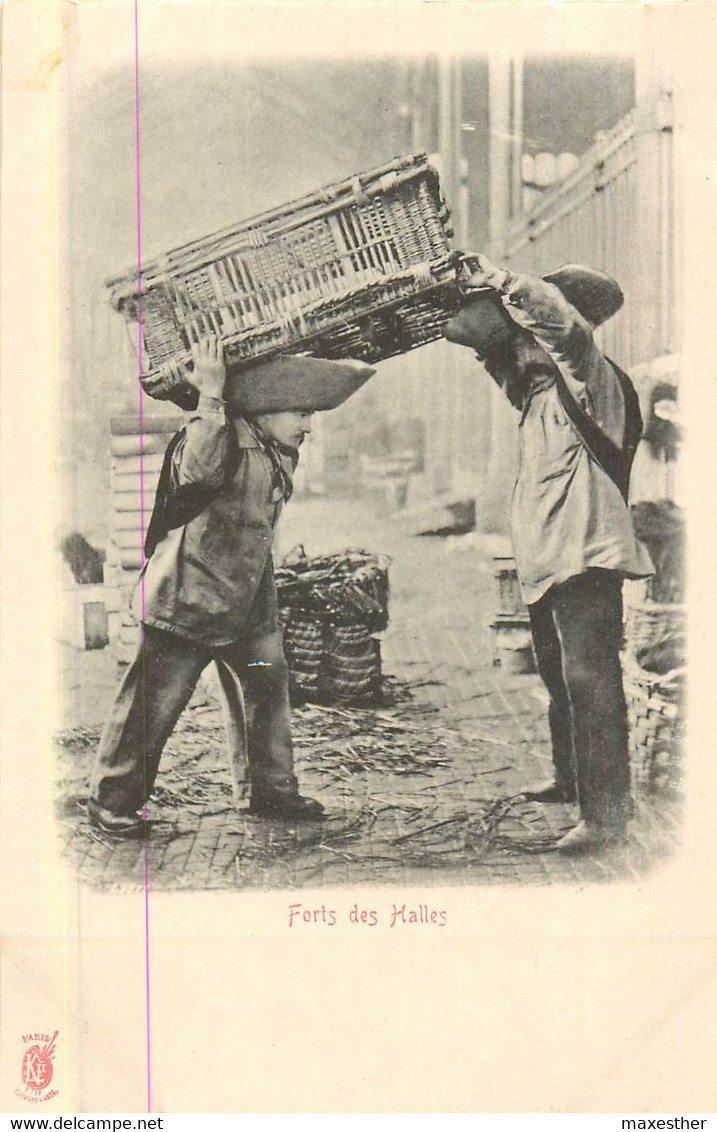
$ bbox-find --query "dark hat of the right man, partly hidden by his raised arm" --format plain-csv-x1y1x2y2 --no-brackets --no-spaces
445,264,624,357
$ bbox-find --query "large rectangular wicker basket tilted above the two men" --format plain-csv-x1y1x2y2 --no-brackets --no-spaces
108,154,460,402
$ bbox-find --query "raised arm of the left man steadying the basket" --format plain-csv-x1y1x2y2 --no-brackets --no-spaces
172,335,231,487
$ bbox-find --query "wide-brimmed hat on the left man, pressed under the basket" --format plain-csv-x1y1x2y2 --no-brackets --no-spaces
224,354,376,413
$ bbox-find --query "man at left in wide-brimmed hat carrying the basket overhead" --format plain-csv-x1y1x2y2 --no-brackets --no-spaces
87,337,374,837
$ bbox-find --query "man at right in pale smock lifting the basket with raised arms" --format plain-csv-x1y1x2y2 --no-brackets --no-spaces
446,256,651,852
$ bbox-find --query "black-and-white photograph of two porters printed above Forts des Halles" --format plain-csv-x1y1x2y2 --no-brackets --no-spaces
58,6,685,890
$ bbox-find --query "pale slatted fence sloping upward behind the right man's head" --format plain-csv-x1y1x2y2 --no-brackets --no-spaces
503,95,680,366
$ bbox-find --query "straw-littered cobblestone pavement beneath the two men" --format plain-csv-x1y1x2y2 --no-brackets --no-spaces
58,499,680,891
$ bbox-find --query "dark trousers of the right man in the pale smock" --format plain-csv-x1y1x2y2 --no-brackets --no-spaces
528,569,630,827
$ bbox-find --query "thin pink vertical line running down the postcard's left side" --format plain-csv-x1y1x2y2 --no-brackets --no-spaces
135,0,152,1113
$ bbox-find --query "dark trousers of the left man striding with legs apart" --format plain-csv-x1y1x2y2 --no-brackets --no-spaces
91,626,297,814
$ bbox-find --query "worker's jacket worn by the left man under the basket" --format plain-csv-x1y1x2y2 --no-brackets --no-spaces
136,397,296,646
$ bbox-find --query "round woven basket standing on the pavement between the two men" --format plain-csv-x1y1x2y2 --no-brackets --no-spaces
276,547,389,703
